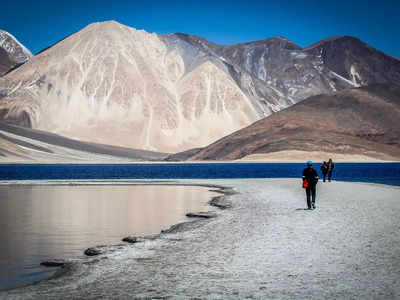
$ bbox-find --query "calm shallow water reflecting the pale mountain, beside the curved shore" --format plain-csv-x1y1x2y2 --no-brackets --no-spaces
0,185,215,289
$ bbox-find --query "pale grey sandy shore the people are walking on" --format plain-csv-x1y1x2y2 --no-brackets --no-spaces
0,179,400,299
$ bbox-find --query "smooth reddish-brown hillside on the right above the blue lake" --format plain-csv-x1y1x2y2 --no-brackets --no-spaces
180,85,400,160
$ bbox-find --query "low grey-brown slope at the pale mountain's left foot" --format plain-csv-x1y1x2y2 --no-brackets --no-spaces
0,122,167,163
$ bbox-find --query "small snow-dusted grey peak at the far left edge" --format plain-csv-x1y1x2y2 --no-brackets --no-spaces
0,30,32,76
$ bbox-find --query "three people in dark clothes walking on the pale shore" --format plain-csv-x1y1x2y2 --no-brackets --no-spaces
303,158,335,209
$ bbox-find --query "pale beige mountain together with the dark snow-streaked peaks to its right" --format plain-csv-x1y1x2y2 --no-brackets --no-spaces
0,21,400,152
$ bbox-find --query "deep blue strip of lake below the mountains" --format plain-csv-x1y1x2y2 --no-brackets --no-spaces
0,163,400,185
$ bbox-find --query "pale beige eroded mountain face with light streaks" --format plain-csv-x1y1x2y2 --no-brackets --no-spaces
0,22,259,152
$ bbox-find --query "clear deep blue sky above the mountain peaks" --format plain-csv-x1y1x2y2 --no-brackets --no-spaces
0,0,400,58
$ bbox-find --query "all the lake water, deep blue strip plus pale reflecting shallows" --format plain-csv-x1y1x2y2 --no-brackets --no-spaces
0,163,400,289
